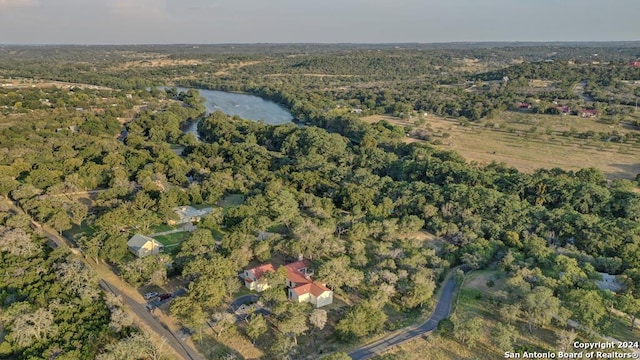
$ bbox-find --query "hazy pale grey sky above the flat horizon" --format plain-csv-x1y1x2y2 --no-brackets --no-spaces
0,0,640,44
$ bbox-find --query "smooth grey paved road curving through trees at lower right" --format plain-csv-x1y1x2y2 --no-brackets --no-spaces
349,275,456,360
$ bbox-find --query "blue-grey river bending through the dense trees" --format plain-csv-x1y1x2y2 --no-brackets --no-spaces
172,87,293,137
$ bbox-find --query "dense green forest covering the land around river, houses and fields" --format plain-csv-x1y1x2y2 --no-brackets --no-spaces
0,46,640,359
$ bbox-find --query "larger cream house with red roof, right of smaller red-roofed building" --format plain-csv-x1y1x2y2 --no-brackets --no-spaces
284,260,333,307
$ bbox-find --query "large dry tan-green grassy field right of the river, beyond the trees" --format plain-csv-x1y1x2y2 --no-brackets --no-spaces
363,112,640,179
